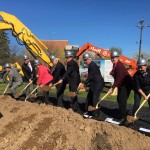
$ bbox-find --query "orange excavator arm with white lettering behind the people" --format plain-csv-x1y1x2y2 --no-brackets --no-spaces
76,43,137,76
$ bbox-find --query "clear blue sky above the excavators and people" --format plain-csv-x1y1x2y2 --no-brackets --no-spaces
0,0,150,57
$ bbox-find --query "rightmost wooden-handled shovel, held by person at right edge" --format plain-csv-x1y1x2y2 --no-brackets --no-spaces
126,94,150,123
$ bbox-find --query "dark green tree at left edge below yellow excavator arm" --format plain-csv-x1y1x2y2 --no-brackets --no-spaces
0,31,11,63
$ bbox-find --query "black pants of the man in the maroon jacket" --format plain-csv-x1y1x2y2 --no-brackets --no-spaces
117,86,131,119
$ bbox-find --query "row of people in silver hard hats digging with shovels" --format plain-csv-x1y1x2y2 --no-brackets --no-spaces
3,51,150,123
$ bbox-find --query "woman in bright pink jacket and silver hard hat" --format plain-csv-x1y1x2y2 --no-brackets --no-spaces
34,59,53,105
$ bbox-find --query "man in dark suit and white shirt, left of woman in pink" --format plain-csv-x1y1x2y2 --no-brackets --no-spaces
22,55,36,97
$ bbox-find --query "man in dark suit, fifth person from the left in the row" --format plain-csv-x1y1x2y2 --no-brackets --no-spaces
58,51,81,113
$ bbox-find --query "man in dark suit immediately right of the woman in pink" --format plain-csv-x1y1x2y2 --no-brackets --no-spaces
50,55,67,107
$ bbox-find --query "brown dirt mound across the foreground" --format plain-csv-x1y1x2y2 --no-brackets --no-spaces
0,96,150,150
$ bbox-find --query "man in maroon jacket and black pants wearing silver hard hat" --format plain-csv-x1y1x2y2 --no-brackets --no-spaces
108,51,132,124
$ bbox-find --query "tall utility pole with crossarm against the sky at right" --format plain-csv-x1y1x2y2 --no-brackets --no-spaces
137,17,150,60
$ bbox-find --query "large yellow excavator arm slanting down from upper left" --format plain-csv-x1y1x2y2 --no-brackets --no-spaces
0,12,52,66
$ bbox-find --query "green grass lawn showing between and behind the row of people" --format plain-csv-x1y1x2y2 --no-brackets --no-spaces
0,83,148,106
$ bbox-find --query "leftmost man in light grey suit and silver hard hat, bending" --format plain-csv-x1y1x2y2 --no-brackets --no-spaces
4,63,23,98
